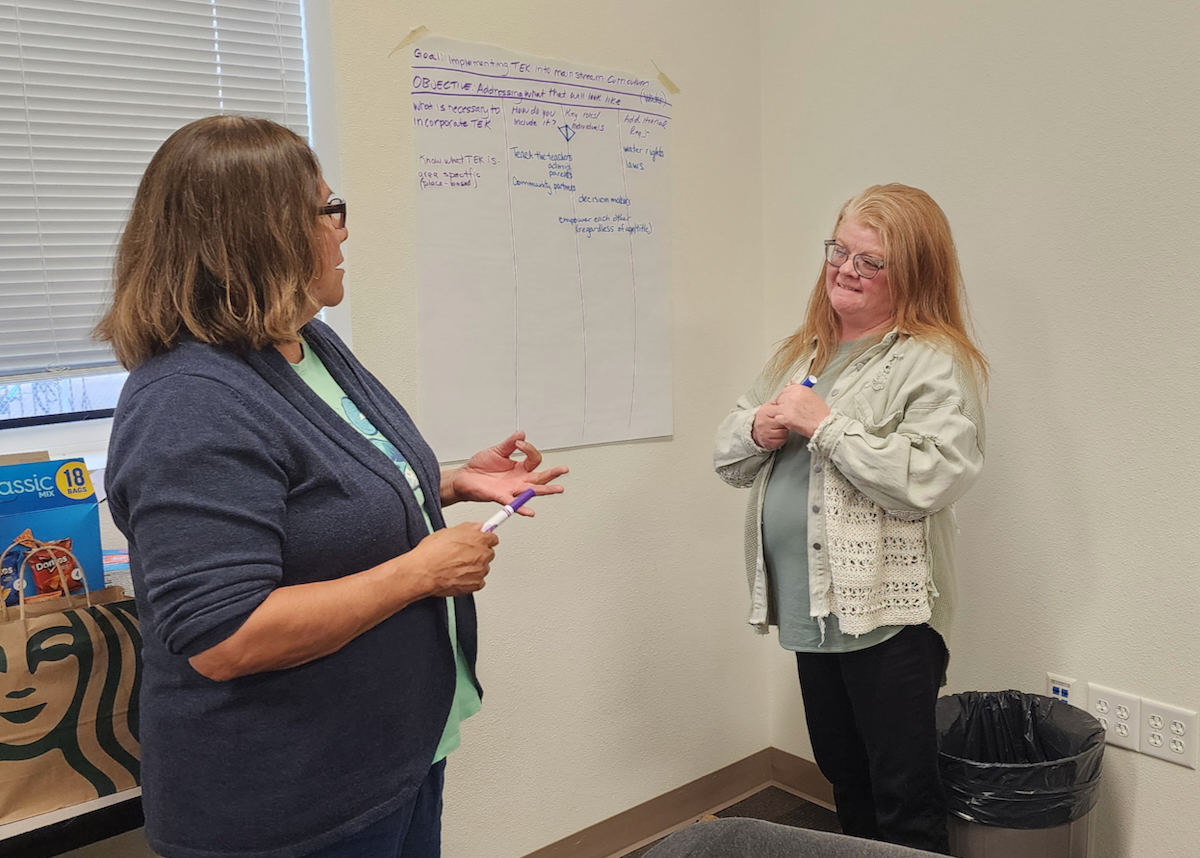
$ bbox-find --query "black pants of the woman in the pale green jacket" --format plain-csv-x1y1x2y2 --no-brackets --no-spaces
796,625,949,854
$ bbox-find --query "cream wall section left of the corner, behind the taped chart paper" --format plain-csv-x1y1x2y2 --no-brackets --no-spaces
334,0,768,858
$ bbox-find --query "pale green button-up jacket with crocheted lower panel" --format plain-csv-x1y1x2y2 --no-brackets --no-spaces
713,331,984,637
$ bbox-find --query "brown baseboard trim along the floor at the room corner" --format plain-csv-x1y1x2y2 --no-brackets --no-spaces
524,748,833,858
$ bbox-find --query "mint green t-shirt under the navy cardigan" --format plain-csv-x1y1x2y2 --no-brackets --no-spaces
292,343,484,762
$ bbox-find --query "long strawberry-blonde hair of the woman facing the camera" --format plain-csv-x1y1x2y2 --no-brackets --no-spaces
767,184,988,385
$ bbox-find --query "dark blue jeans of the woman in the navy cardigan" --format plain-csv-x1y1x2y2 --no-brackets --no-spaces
306,760,446,858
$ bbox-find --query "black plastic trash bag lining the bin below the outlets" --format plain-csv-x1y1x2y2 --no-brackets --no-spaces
937,691,1104,828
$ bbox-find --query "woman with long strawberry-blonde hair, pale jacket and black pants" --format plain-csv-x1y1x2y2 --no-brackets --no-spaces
714,185,988,853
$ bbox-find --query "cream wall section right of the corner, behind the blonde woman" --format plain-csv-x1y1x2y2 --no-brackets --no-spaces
761,0,1200,858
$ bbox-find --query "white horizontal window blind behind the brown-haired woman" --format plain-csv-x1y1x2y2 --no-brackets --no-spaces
0,0,310,380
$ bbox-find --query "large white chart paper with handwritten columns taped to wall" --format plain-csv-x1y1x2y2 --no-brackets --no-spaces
408,36,673,460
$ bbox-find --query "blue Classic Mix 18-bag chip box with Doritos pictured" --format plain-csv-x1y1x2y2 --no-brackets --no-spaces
0,460,104,605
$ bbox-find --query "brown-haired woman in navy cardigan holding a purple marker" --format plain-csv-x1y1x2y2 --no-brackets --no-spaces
97,116,566,858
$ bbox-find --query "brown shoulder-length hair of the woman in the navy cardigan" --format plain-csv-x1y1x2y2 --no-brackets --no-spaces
95,116,323,370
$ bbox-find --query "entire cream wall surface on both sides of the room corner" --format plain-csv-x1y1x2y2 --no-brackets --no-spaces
63,0,1200,858
